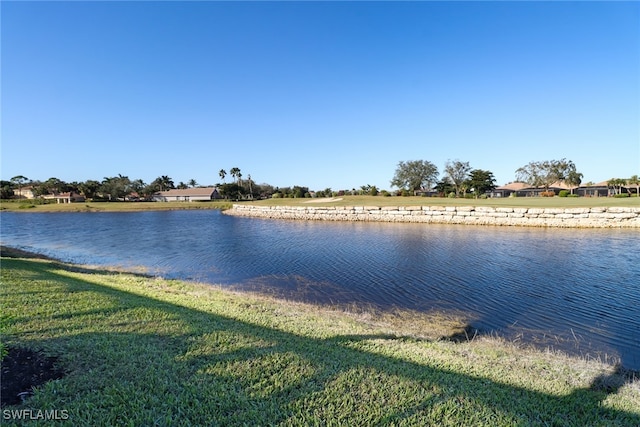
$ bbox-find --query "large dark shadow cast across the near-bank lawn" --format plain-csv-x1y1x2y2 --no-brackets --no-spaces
2,260,640,426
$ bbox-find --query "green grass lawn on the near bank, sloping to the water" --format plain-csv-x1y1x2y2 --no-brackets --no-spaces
0,258,640,426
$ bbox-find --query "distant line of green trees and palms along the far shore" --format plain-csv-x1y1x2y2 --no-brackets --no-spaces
0,158,640,201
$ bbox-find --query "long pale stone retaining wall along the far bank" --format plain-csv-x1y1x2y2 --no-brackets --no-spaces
224,204,640,228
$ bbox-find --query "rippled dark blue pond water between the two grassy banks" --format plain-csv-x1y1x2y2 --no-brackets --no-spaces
0,210,640,369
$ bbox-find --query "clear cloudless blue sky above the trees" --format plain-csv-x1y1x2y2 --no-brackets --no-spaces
0,1,640,190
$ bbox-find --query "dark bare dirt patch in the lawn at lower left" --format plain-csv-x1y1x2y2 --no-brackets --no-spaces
0,348,64,407
